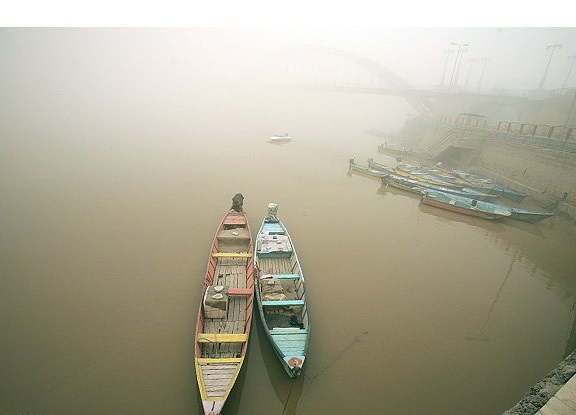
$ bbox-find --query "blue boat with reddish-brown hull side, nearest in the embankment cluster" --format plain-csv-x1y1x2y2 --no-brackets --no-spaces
420,190,511,219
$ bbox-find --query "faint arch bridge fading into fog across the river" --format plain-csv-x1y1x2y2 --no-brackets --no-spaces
258,45,538,121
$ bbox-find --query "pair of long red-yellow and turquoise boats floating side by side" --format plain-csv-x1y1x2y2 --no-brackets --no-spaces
194,193,311,415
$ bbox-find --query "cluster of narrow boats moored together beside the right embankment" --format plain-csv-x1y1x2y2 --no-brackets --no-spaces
350,159,554,223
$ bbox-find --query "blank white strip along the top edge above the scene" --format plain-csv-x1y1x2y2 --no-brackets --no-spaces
0,0,574,28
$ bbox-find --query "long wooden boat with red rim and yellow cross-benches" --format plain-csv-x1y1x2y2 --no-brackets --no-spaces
194,194,254,415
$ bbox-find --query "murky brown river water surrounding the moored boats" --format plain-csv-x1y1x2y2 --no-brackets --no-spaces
0,39,576,415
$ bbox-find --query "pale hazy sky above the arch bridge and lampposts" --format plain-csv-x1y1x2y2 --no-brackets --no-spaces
0,27,576,94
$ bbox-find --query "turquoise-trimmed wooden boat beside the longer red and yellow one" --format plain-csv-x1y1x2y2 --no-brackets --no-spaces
254,203,311,378
